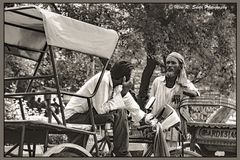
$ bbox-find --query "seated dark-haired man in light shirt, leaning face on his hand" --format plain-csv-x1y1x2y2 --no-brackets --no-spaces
65,61,145,156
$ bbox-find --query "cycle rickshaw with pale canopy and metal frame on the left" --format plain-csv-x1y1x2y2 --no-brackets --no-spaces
4,6,119,157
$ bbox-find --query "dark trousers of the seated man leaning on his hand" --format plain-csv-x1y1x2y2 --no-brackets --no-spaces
66,109,131,157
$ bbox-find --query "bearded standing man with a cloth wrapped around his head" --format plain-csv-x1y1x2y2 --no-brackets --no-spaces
146,52,199,156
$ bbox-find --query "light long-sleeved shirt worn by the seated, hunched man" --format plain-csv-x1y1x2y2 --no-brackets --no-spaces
64,71,145,122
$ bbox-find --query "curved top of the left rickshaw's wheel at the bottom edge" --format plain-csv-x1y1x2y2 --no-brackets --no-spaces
43,143,92,157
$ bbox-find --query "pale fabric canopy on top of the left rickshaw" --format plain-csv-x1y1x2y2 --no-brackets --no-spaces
5,6,119,60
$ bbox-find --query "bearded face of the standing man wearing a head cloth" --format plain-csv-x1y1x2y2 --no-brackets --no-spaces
166,57,181,77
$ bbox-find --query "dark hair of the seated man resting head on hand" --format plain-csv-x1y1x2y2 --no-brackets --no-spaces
110,61,134,81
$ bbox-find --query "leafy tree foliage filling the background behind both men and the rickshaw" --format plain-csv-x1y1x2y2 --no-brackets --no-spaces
5,3,236,99
